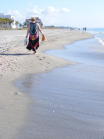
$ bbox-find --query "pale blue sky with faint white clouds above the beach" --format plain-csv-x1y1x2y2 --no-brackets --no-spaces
0,0,104,28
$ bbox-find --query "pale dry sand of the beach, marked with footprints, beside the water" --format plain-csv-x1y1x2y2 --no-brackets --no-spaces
0,29,92,139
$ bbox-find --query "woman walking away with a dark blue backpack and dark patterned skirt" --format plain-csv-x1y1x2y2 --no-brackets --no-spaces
26,17,44,54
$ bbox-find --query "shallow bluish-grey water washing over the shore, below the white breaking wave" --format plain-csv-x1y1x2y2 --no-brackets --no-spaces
17,39,104,139
